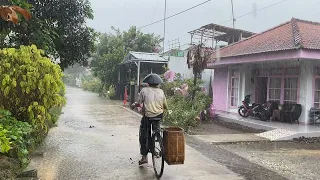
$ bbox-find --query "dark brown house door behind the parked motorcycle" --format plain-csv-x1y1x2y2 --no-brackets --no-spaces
255,77,268,103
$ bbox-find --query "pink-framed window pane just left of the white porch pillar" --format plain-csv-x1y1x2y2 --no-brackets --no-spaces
283,77,298,103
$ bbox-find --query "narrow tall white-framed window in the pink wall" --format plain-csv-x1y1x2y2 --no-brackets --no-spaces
230,69,240,107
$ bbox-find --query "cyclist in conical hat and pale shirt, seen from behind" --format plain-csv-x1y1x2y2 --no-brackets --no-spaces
136,74,168,165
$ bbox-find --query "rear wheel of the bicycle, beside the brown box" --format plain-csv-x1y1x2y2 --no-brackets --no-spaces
152,133,164,178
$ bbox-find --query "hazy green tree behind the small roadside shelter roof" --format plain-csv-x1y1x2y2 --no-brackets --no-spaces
90,26,161,93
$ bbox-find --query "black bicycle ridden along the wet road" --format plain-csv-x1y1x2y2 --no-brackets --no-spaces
139,117,164,179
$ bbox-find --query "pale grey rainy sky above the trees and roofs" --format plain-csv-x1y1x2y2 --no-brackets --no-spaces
88,0,320,49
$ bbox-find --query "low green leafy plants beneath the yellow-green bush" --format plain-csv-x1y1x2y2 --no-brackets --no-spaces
0,109,35,167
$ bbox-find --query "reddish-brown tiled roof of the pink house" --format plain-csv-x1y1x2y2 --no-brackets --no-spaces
212,18,320,60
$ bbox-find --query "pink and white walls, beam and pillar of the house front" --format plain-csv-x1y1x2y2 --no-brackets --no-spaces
213,60,320,124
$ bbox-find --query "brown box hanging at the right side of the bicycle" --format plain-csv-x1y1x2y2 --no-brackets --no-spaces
163,127,185,165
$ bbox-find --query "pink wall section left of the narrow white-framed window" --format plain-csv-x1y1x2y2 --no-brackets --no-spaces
212,68,228,111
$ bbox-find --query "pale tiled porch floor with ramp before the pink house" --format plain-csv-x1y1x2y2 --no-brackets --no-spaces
218,112,320,141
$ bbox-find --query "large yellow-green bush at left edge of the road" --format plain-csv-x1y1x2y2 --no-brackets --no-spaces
0,45,65,132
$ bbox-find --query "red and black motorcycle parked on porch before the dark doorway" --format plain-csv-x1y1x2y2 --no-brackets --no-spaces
238,94,268,121
